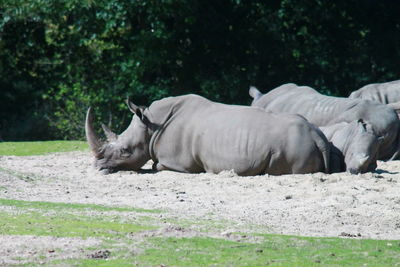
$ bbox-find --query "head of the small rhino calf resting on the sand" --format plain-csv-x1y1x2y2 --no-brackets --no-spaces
332,119,383,174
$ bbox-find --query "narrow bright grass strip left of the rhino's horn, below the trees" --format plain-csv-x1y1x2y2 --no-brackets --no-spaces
0,141,88,156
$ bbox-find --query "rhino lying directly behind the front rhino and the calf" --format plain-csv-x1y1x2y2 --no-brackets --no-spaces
249,83,400,160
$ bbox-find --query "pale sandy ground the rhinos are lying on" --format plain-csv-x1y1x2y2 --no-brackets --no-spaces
0,152,400,242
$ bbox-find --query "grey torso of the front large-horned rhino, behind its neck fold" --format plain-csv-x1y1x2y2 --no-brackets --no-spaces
148,97,324,175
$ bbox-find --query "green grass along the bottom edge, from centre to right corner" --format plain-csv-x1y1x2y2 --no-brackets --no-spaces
137,235,400,266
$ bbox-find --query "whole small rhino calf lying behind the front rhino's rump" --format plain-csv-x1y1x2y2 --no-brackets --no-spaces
320,120,382,174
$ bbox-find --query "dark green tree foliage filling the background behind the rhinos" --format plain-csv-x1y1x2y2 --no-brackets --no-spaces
0,0,400,140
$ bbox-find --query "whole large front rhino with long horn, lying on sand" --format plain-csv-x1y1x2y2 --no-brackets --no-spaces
86,95,330,175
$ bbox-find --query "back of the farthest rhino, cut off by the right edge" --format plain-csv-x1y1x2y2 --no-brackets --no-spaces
349,80,400,104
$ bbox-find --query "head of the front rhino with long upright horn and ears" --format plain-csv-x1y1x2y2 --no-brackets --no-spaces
85,99,151,174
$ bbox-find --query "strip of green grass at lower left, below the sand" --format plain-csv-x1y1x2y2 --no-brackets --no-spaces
0,199,158,238
